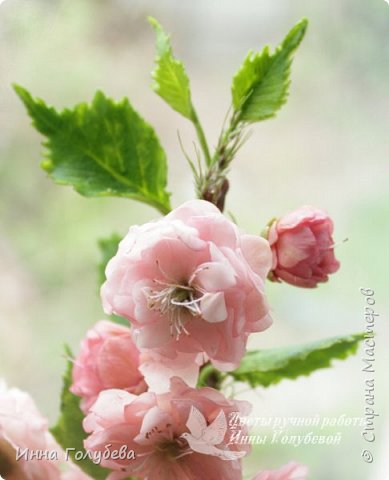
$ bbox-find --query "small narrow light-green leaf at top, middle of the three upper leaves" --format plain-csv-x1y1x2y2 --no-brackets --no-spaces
149,17,194,120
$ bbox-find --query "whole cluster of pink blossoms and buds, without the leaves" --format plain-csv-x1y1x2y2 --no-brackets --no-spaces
0,200,339,480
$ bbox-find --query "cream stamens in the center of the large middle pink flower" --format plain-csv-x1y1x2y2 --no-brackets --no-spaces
147,280,202,340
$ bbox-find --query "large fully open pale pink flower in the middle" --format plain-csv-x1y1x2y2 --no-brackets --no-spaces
102,200,271,370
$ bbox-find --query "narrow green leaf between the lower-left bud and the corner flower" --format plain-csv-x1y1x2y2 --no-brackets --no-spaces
51,347,109,480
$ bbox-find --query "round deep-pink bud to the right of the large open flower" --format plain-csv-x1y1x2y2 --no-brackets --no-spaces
269,207,339,288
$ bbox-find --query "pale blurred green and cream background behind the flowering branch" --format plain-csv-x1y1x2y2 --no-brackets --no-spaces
0,0,389,480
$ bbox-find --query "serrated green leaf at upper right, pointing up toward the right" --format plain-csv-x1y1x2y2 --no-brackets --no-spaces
232,19,308,122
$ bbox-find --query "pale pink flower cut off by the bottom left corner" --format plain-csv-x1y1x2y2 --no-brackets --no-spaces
0,382,91,480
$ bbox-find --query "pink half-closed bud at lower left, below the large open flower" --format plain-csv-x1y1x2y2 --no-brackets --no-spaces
70,320,147,413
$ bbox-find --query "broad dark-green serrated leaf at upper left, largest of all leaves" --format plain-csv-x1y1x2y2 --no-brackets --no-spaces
15,86,170,213
